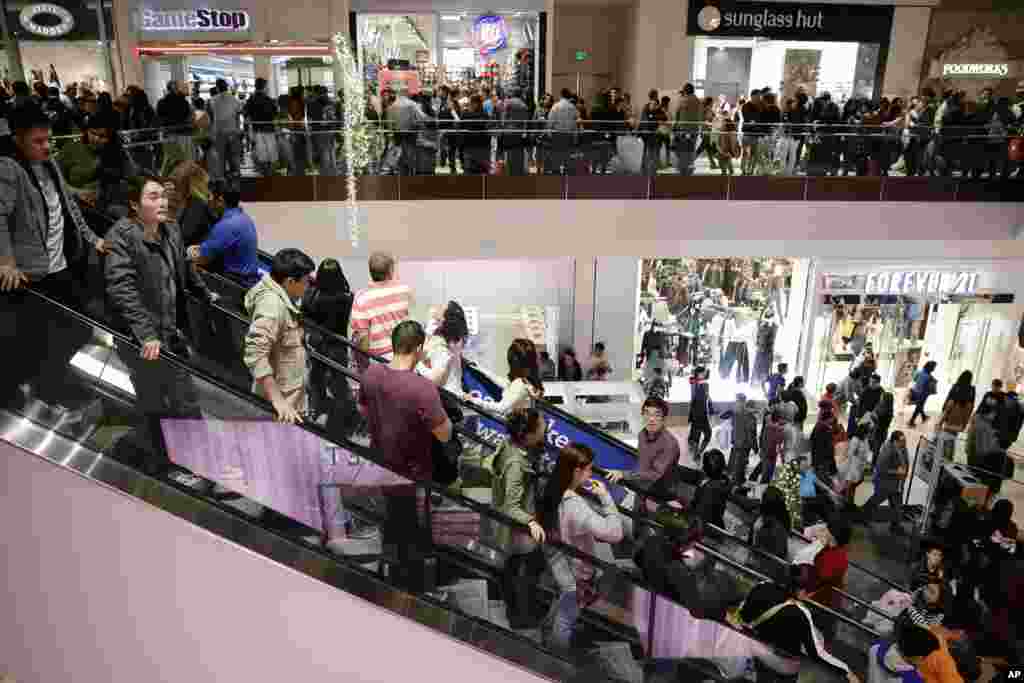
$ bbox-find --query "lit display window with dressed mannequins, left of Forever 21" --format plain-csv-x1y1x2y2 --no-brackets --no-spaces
634,257,807,402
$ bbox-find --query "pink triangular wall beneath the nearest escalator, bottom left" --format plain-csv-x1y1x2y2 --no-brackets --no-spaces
0,442,545,683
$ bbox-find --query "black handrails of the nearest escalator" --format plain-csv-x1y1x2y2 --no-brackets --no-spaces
19,287,879,658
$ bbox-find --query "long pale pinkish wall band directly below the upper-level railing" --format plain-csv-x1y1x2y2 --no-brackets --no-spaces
246,200,1024,260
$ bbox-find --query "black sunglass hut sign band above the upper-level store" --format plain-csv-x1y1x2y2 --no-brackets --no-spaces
686,0,893,44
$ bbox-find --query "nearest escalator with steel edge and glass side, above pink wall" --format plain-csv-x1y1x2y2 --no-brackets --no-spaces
0,292,873,681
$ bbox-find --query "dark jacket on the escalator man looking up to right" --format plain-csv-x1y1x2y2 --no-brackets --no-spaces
104,218,210,344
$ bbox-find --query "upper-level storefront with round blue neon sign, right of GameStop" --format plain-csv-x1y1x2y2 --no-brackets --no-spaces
356,11,539,97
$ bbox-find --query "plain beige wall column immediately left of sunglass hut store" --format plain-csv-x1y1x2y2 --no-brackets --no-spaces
626,0,696,106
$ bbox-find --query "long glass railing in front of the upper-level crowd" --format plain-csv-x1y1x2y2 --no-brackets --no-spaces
51,121,1024,202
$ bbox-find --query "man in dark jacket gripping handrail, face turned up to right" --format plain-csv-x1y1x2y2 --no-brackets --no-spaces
105,176,214,471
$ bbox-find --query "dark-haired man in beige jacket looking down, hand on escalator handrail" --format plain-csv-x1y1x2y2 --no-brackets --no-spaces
244,249,316,424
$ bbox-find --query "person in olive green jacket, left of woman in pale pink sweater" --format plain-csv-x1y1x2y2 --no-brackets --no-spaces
492,408,547,629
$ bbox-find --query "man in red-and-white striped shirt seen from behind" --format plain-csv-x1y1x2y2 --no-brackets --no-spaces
350,252,413,359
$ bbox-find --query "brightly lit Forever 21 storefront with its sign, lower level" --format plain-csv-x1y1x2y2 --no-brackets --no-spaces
808,270,1024,448
